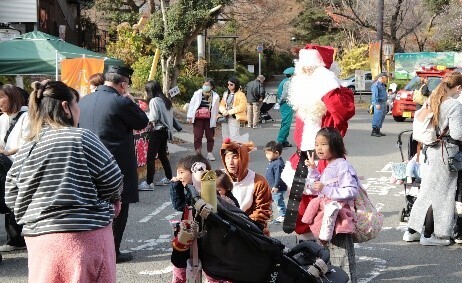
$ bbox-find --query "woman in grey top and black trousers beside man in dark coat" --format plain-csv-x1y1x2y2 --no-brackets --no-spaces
139,81,179,191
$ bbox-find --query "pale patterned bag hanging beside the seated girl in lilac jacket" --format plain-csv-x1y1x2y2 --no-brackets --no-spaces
352,182,383,243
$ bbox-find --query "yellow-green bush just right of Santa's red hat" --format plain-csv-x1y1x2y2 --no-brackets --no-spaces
338,44,370,77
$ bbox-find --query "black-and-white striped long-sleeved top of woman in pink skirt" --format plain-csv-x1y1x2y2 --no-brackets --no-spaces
5,127,123,236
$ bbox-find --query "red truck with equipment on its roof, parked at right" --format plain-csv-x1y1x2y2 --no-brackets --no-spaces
392,66,455,122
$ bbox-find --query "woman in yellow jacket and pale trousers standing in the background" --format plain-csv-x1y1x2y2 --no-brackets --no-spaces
219,77,247,141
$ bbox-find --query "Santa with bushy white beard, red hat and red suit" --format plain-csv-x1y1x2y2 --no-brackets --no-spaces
281,44,355,237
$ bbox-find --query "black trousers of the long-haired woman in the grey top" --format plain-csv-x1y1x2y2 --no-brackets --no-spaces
146,128,173,184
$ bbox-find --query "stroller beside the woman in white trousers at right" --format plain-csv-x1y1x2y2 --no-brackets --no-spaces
393,130,420,222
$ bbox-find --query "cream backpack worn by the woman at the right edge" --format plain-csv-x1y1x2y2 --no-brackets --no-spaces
412,102,438,145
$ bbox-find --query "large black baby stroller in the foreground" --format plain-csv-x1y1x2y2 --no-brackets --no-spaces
187,186,349,283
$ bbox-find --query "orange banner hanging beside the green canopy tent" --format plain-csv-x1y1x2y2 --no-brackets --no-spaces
61,57,104,96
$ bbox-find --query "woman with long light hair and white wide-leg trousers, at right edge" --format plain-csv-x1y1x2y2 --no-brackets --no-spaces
403,74,462,246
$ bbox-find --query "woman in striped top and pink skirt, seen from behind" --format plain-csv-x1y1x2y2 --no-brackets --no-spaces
5,81,123,283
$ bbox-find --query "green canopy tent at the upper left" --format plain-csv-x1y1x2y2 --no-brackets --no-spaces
0,31,125,77
